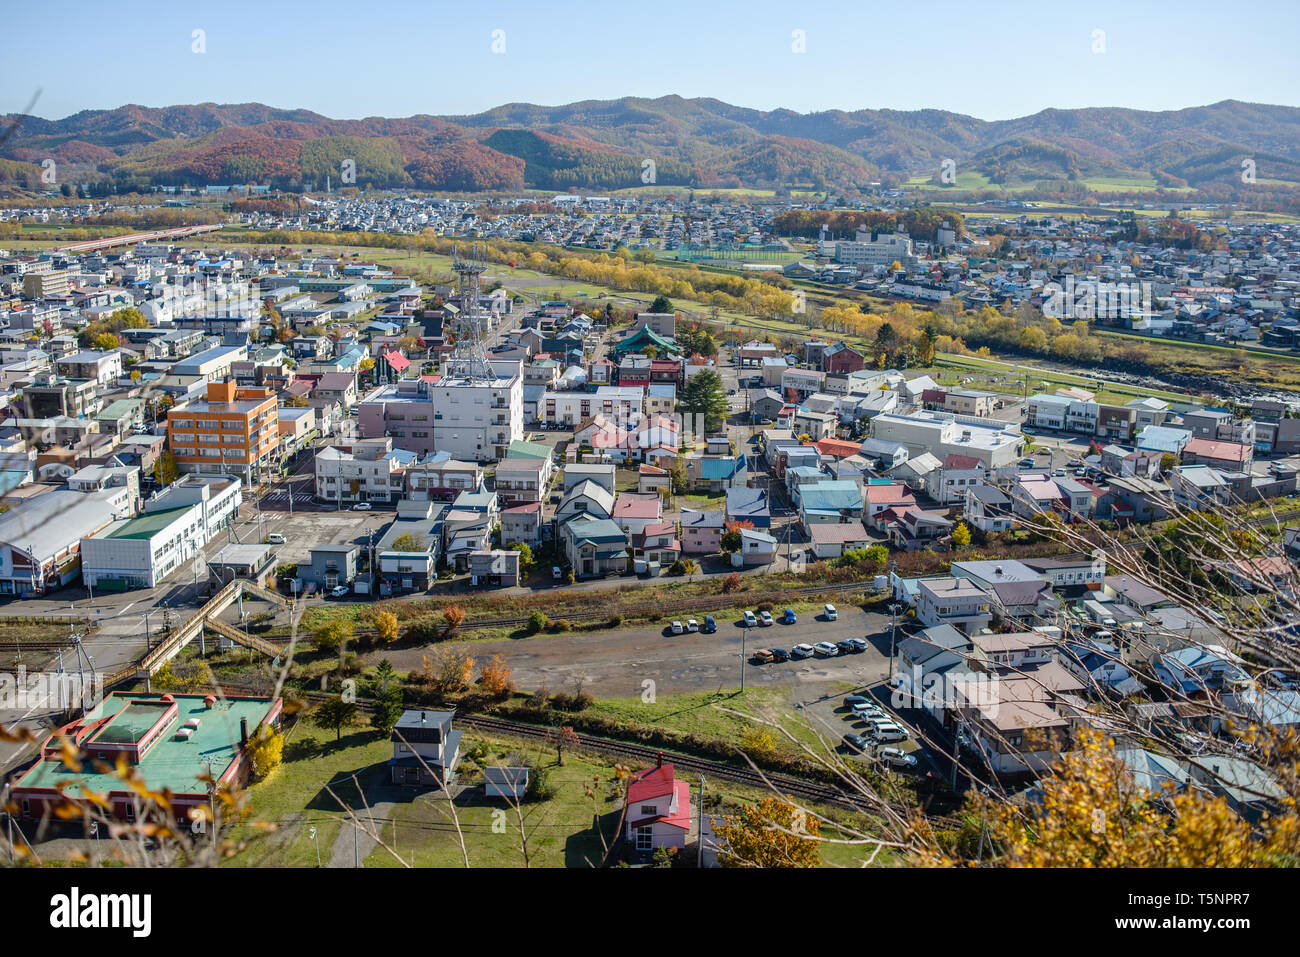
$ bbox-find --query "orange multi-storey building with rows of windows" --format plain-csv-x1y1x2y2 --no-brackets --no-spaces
166,381,280,484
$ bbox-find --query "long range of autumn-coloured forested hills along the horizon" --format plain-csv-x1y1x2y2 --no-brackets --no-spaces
0,96,1300,191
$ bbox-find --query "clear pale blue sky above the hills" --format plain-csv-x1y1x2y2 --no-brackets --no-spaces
0,0,1300,120
